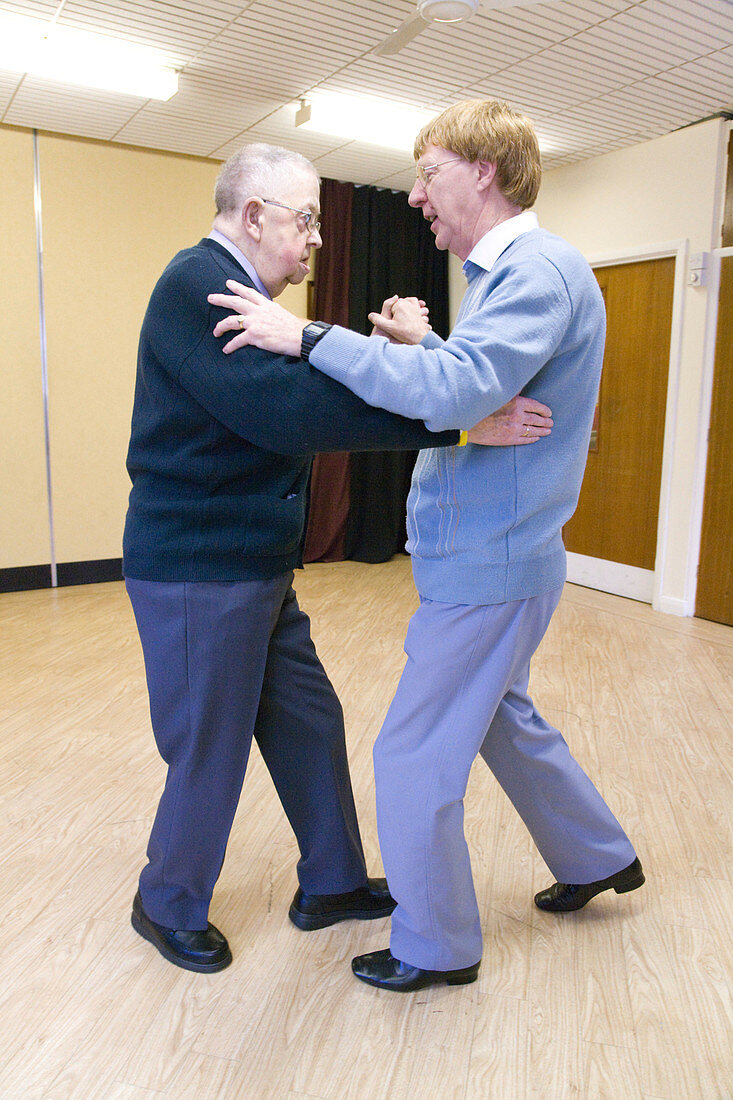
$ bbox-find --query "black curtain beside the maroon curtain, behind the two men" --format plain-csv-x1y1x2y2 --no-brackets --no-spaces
344,186,449,562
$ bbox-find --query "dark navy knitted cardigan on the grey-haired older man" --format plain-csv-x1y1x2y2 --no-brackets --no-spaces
123,238,458,581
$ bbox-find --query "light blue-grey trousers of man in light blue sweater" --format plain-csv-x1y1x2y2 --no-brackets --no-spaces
374,589,635,970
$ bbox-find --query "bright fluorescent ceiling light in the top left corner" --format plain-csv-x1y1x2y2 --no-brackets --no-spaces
0,14,178,100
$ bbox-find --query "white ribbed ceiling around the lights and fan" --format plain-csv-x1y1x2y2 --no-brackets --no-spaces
0,0,733,189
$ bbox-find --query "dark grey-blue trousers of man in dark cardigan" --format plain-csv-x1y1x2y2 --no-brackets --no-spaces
127,573,367,928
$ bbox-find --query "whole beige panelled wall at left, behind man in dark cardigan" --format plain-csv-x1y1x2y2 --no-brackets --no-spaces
0,128,306,569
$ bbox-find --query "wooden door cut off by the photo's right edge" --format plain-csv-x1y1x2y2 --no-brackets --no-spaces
694,256,733,626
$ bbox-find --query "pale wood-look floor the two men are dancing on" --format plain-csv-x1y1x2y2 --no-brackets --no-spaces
0,559,733,1100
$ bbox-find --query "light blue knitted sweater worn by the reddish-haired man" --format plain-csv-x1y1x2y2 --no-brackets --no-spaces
310,229,605,604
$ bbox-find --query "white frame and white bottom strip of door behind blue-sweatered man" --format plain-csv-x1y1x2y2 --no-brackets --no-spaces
568,238,686,615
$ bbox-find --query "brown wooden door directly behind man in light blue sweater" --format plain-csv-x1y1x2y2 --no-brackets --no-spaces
564,257,675,570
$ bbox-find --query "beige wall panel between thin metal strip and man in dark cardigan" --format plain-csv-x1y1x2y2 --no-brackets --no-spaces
40,135,218,562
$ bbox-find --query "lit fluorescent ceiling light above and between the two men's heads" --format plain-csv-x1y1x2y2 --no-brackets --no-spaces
295,92,436,153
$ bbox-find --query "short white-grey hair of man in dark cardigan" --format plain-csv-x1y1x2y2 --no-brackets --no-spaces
214,142,318,215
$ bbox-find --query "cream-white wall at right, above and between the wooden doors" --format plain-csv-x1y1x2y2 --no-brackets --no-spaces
450,119,730,615
